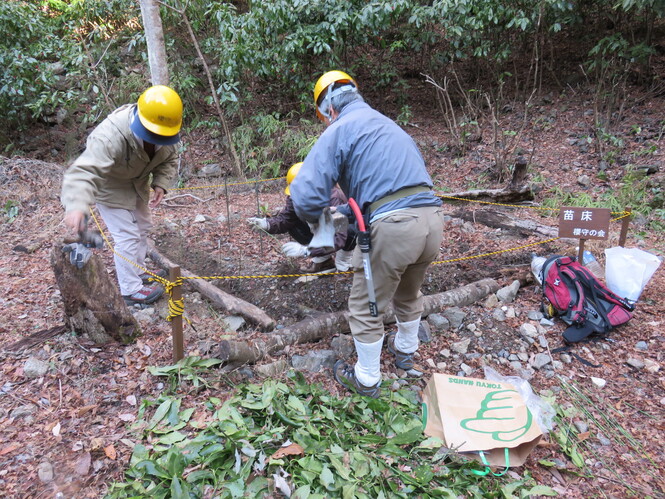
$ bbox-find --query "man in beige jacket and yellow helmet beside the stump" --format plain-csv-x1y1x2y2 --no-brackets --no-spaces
61,85,182,305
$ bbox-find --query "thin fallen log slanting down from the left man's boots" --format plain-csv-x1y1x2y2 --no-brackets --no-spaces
148,244,276,331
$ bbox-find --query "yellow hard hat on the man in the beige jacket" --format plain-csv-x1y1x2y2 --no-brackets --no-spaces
137,85,182,137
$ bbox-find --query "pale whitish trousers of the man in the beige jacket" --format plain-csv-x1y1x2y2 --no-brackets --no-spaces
97,198,152,296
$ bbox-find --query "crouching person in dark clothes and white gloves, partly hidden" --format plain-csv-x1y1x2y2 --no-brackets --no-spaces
247,163,356,273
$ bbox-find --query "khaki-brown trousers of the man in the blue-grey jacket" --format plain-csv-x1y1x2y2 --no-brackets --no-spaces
349,206,443,343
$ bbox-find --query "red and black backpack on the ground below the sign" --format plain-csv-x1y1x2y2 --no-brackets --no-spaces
540,255,635,343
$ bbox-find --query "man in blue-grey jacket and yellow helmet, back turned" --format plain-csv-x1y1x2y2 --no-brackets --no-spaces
291,71,443,397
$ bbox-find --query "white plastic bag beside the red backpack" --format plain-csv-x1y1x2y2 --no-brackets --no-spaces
605,246,660,302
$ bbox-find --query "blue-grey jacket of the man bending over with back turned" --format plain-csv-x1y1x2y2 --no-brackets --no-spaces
290,101,441,222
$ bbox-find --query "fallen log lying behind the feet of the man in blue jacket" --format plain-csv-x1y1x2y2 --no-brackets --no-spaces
215,279,499,365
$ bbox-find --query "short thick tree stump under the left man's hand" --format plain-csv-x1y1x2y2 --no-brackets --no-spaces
51,245,141,343
